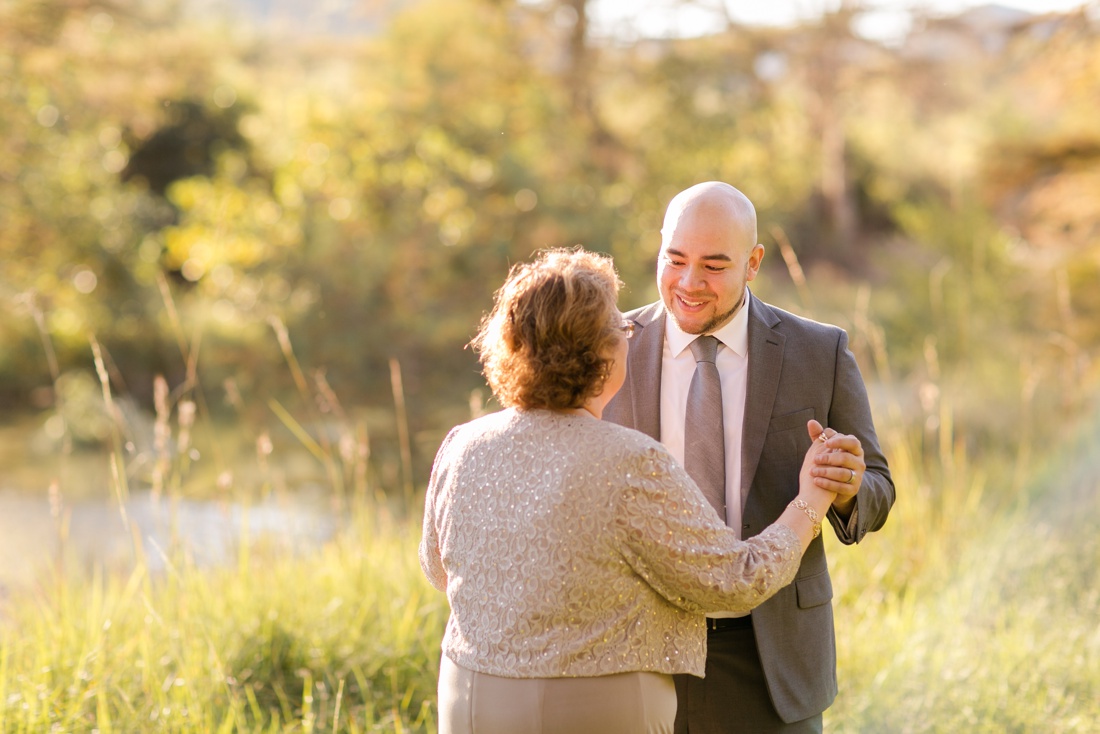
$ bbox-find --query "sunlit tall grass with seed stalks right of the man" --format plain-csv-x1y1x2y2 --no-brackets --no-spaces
777,233,1100,734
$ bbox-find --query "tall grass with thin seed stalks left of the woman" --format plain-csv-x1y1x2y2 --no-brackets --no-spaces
0,308,447,733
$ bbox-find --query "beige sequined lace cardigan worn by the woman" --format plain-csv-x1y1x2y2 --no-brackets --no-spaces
420,409,800,678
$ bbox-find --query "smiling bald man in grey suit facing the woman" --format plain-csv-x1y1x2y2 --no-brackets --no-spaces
604,182,894,734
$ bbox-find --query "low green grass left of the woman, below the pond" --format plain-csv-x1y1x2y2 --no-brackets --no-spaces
0,493,447,732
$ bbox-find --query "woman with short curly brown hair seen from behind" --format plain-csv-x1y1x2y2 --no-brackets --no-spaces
420,249,848,734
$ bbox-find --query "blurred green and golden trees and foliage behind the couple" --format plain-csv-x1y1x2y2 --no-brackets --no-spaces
0,0,1100,481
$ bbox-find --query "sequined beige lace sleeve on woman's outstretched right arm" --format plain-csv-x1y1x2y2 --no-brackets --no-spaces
616,448,801,613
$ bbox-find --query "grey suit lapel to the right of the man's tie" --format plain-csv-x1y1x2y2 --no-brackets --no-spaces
741,296,785,514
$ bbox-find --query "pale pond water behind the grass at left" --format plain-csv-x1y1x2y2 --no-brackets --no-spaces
0,413,341,591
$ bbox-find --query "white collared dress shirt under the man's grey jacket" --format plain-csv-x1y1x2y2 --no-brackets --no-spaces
661,292,749,537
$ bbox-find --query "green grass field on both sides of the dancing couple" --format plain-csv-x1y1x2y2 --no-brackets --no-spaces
0,411,1100,733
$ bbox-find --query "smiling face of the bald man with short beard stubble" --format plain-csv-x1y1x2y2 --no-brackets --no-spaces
657,213,763,333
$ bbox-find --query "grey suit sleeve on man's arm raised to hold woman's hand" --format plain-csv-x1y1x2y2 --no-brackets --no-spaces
826,330,894,545
